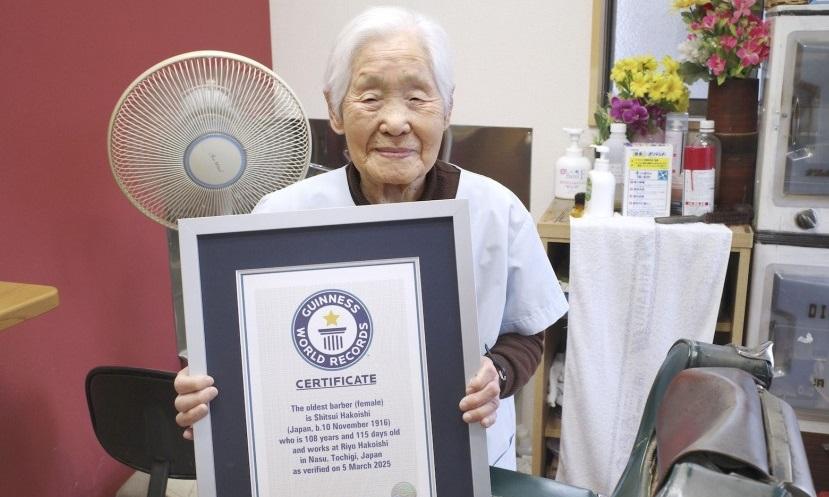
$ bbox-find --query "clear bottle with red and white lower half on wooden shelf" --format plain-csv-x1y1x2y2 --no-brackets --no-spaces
682,120,720,216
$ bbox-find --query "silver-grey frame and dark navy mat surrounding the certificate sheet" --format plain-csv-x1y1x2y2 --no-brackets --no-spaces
179,200,490,497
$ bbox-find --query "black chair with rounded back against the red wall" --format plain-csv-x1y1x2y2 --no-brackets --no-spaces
86,367,196,497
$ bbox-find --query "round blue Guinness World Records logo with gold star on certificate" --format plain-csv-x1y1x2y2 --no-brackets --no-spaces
291,289,373,371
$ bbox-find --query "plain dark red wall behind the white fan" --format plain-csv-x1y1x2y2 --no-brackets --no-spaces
0,0,271,497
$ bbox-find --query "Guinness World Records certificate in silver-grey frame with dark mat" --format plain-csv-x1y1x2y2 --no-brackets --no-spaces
179,200,490,497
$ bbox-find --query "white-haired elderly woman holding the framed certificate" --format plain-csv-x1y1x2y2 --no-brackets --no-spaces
171,7,567,469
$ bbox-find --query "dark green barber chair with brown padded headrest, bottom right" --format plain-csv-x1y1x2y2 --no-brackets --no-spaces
491,340,815,497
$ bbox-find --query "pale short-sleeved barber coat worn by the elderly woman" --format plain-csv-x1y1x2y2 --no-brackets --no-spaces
253,166,567,469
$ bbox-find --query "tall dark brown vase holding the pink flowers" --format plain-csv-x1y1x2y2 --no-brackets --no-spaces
706,78,759,208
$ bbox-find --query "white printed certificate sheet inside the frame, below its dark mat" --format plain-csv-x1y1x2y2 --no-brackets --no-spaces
237,258,436,497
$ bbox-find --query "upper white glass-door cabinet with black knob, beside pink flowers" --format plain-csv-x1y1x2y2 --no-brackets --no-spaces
755,4,829,234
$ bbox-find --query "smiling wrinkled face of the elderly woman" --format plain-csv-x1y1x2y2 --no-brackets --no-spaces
331,33,449,193
